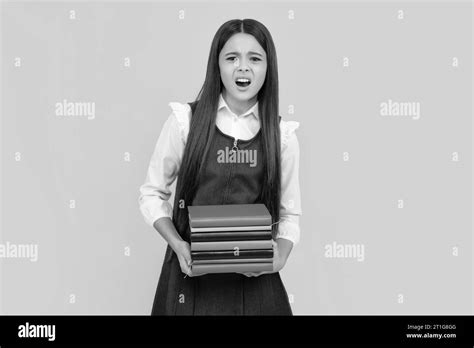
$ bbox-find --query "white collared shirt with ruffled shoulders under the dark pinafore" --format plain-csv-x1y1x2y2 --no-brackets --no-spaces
138,94,302,245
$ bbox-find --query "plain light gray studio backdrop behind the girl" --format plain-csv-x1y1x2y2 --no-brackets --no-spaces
0,1,473,314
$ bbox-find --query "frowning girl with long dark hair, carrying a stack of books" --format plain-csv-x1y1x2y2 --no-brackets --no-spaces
139,19,301,315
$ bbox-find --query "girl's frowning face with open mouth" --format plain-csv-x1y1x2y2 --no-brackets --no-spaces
219,33,267,105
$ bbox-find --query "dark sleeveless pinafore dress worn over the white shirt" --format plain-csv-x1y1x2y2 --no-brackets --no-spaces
151,103,293,315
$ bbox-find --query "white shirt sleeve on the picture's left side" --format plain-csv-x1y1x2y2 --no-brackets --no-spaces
138,103,188,226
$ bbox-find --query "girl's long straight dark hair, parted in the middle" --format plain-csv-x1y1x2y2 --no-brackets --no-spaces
173,19,281,239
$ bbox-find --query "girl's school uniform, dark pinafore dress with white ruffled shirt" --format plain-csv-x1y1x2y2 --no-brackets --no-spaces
139,95,301,315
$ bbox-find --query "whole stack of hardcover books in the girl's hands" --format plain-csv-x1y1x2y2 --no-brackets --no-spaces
188,204,273,275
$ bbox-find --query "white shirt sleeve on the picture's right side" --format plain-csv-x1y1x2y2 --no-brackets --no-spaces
276,121,302,246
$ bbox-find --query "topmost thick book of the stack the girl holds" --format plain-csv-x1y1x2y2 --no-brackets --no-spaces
188,204,272,227
